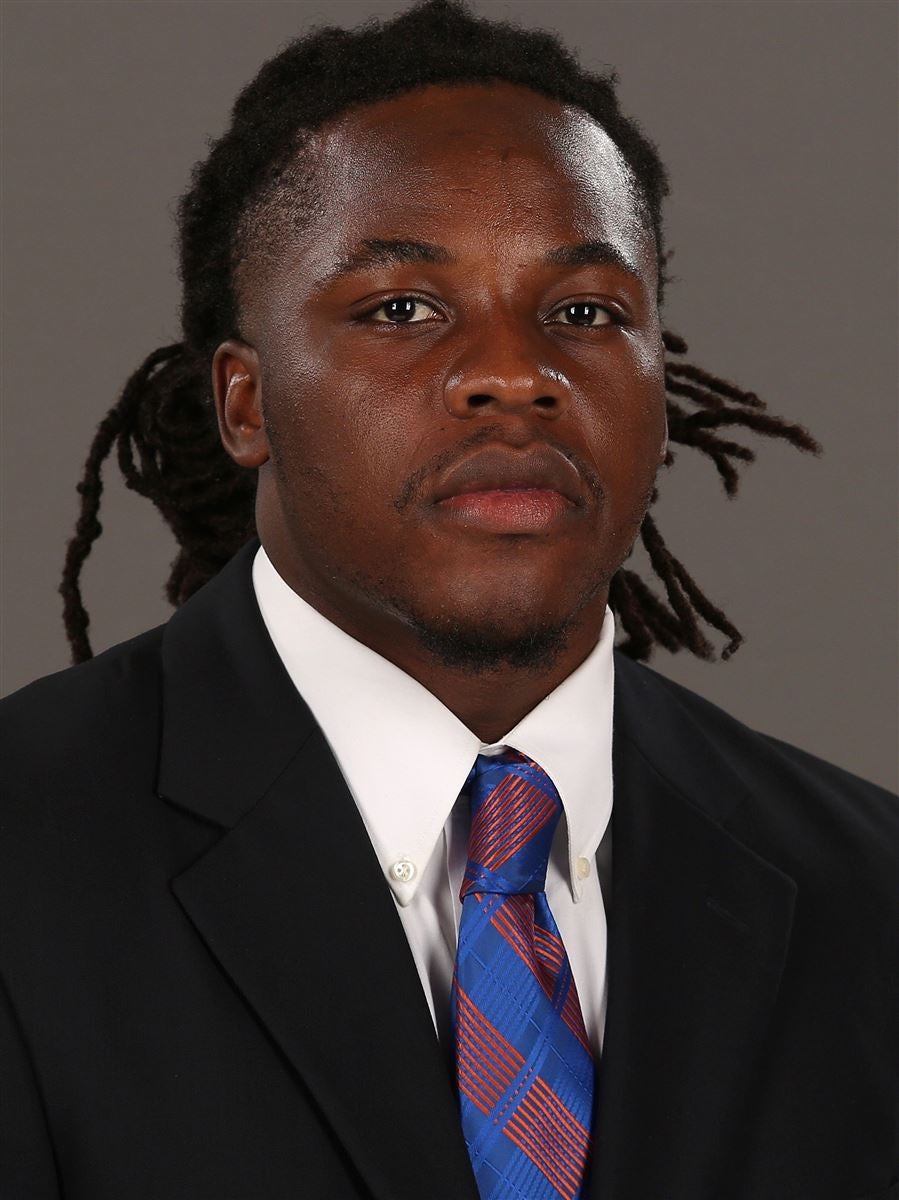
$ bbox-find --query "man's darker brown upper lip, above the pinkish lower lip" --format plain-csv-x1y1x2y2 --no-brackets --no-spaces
433,445,583,506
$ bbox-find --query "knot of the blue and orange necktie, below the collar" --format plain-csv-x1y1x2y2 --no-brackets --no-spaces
459,750,562,900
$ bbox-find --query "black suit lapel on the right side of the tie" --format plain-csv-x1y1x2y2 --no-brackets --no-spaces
587,654,797,1200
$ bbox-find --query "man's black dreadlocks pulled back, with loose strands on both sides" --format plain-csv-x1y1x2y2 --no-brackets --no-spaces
59,0,820,662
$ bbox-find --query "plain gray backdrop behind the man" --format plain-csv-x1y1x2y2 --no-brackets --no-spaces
2,0,899,788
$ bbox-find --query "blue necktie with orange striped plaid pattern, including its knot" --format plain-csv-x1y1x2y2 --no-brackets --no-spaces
451,750,594,1200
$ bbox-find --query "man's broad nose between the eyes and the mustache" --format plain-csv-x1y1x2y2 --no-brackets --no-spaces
444,324,571,419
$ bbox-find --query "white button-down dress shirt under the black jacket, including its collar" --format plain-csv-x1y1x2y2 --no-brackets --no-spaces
253,546,615,1058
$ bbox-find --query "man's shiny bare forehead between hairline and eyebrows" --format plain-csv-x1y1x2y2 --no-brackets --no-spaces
300,82,655,270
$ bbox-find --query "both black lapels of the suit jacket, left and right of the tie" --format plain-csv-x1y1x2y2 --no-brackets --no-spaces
158,540,796,1200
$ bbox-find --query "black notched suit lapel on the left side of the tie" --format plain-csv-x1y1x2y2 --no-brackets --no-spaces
158,541,477,1200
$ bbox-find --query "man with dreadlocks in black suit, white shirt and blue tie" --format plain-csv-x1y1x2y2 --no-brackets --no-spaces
0,2,899,1200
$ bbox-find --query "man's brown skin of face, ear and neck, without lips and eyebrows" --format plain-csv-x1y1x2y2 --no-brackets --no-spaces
212,83,667,743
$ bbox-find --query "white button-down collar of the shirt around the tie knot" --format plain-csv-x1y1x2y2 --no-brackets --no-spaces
252,546,615,906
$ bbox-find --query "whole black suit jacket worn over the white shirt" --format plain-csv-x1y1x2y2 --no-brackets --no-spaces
0,541,899,1200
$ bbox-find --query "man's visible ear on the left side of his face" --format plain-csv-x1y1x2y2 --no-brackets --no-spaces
212,338,269,467
